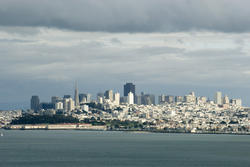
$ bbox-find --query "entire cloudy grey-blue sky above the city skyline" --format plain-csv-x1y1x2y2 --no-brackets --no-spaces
0,0,250,109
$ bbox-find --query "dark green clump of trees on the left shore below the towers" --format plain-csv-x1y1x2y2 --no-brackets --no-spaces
11,115,79,125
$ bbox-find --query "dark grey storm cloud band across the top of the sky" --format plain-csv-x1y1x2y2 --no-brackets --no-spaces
0,0,250,32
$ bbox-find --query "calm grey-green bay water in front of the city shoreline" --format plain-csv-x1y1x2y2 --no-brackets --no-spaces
0,130,250,167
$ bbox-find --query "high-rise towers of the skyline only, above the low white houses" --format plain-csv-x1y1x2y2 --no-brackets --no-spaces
27,82,242,112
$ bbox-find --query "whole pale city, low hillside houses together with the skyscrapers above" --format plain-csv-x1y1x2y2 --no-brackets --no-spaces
1,83,250,133
